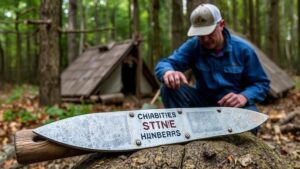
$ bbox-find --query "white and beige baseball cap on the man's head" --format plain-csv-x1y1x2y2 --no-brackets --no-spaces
188,4,222,36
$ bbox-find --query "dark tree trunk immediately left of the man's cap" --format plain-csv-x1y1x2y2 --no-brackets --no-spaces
171,0,186,50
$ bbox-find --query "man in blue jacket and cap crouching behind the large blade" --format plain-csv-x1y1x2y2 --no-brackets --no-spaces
155,4,270,111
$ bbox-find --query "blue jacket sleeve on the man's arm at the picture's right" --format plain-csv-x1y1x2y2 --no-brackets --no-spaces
241,49,270,105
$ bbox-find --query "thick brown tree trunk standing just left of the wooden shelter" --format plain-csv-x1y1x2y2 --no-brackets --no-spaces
39,0,61,106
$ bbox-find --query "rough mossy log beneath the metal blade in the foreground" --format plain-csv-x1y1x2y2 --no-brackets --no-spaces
74,133,292,169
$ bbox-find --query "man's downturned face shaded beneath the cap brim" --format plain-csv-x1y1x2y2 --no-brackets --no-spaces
198,20,224,49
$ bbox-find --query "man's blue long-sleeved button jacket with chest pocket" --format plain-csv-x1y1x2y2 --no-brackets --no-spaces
155,28,270,105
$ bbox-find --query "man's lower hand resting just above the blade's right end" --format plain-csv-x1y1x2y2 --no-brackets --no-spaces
218,93,247,107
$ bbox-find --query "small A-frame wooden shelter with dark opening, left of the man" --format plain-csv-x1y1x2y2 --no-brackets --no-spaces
61,40,159,102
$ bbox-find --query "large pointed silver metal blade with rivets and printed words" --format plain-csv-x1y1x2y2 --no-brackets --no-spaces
34,107,268,152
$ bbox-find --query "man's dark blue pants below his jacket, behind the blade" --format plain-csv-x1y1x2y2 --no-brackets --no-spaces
160,85,259,135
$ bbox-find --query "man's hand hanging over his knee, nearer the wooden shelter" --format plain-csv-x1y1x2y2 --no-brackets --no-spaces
163,70,188,89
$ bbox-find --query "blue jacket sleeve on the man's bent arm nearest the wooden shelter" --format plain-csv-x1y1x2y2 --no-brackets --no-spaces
155,37,199,82
